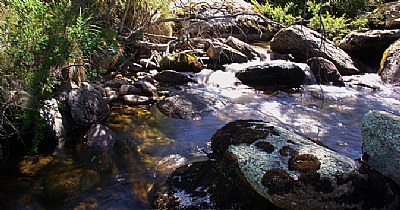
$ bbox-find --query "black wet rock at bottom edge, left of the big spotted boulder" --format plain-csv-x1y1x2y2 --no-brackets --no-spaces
151,161,280,210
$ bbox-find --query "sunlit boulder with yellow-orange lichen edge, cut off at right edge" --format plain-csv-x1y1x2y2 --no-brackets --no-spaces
378,39,400,86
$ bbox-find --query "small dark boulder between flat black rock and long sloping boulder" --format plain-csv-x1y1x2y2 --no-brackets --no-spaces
307,57,344,87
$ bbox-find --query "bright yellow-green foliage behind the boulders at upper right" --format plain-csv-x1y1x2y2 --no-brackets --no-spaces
253,0,368,41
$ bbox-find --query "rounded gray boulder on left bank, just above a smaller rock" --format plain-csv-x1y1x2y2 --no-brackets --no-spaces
68,82,109,126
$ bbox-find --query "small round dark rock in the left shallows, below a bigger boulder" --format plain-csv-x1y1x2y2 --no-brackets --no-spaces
85,124,115,152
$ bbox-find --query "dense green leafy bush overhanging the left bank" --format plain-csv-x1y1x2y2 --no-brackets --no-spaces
0,0,117,152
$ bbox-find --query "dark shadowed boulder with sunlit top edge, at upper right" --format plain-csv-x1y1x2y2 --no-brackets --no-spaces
339,29,400,67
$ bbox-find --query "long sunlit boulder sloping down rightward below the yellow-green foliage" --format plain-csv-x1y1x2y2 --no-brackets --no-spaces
270,25,361,75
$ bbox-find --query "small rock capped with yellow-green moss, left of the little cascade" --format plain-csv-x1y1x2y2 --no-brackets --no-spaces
160,52,204,73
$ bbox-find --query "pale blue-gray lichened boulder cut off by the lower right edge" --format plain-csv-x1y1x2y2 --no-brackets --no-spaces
362,110,400,185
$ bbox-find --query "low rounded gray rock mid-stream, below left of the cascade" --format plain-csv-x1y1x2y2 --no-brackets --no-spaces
157,93,209,119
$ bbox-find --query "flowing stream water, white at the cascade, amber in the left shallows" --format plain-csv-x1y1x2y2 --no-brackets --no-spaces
0,58,400,209
